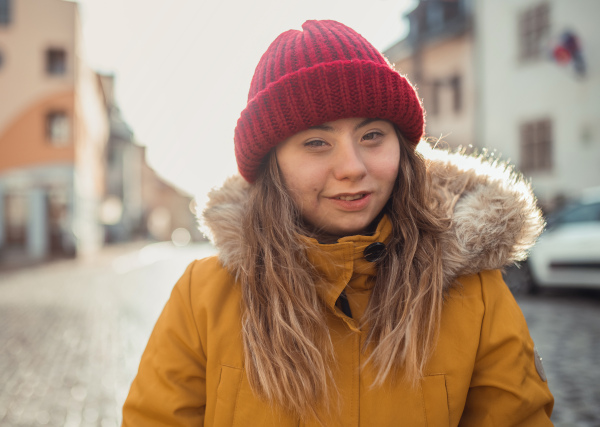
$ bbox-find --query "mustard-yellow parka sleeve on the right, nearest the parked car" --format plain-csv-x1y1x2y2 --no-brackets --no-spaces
460,270,554,427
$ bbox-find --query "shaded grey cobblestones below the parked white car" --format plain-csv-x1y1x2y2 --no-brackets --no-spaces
517,290,600,427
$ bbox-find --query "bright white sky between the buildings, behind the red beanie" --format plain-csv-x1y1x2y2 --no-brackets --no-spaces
79,0,416,199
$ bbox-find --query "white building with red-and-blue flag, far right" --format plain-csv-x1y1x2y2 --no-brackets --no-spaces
475,0,600,209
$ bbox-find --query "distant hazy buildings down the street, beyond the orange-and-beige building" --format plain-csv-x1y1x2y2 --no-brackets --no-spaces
100,75,202,244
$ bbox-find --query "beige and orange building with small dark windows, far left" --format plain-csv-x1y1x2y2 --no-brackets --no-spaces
0,0,109,262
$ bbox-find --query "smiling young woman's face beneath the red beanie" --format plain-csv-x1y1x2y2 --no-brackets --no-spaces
275,118,400,239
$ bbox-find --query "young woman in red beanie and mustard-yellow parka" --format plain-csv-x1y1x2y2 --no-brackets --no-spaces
123,21,553,427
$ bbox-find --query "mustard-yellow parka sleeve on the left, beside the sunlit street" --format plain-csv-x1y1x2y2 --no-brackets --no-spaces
123,264,206,427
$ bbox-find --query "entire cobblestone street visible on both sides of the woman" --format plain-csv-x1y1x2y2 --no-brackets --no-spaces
0,244,600,427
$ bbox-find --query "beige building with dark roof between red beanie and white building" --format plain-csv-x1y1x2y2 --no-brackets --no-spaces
384,0,475,147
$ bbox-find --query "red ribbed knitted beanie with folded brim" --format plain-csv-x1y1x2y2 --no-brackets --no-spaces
234,21,424,182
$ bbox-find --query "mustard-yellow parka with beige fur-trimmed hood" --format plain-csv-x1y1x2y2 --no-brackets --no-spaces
123,145,553,427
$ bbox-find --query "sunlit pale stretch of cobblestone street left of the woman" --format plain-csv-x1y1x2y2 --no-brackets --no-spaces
0,244,214,427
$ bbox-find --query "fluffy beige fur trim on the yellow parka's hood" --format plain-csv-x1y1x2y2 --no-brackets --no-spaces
200,142,544,285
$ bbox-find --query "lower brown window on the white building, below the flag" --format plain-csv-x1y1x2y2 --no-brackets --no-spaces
521,119,552,172
